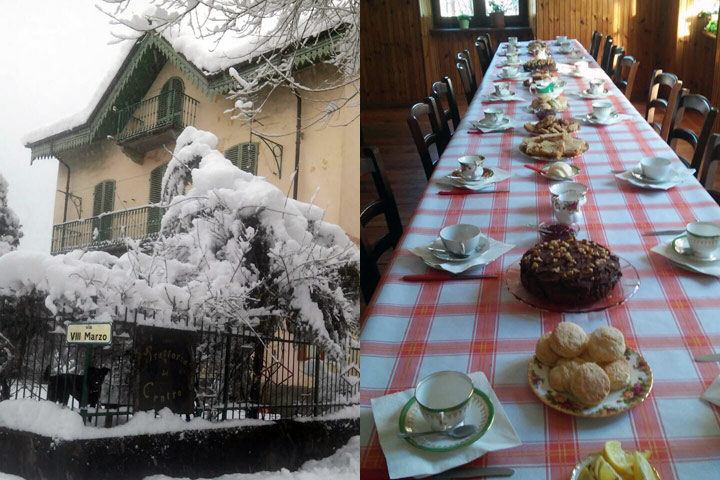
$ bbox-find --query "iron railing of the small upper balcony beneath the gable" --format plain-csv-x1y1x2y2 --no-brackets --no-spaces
117,90,198,142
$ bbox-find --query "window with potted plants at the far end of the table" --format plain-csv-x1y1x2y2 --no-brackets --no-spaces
432,0,528,28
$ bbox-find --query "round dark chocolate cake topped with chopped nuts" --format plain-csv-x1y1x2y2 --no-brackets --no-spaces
520,238,622,305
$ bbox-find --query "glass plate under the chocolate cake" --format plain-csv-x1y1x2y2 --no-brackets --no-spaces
505,257,640,313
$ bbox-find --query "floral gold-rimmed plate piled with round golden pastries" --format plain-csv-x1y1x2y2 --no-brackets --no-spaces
527,322,653,417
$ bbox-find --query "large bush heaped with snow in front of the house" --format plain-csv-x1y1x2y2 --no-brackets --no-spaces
0,127,360,358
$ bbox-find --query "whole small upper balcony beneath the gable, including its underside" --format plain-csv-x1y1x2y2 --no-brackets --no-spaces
115,90,198,163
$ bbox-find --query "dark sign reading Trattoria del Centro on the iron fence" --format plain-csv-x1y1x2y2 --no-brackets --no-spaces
133,326,195,413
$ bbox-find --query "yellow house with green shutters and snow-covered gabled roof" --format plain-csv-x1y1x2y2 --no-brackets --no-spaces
25,29,359,254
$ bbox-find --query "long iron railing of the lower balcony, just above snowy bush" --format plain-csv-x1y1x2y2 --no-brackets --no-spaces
50,205,165,255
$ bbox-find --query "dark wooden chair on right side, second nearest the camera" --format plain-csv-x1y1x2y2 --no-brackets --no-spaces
667,89,718,172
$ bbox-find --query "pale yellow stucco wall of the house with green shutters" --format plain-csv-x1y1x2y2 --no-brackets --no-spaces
54,62,360,241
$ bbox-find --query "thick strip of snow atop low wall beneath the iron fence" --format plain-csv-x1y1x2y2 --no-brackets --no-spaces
0,399,273,440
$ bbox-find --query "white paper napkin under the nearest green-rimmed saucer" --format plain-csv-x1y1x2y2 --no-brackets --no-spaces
371,372,522,478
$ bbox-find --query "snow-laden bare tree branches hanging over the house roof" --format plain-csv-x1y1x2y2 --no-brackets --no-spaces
99,0,360,122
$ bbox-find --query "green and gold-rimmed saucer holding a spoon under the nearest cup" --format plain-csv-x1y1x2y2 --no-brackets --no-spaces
400,388,495,452
